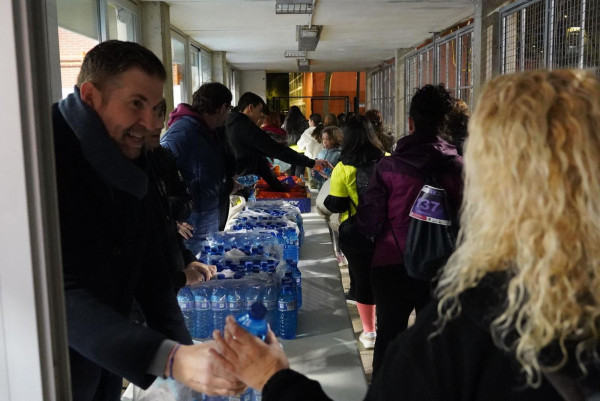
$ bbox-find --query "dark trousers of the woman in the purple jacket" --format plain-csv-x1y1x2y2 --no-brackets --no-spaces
371,265,431,377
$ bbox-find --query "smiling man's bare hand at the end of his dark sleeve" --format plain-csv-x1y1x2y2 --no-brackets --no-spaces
165,341,246,395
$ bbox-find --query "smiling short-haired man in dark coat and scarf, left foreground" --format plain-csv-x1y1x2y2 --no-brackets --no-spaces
52,41,243,401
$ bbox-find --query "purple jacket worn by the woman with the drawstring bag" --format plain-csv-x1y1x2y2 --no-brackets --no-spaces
357,133,463,267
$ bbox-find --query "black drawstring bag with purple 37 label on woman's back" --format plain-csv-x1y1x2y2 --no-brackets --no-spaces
392,176,458,281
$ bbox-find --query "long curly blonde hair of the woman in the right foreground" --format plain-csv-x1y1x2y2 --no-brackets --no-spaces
436,70,600,387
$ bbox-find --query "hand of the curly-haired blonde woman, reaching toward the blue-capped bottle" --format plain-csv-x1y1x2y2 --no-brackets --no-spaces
211,316,290,391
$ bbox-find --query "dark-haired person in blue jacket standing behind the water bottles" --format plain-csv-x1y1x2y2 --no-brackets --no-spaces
160,82,235,253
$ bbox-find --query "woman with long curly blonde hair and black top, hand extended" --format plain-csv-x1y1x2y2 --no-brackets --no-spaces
210,70,600,401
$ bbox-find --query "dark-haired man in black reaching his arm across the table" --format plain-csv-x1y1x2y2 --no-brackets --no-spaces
225,92,333,192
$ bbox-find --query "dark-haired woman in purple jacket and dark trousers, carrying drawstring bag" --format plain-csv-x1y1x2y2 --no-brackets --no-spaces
357,85,463,375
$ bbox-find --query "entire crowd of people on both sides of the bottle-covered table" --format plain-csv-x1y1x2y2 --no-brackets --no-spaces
52,41,600,401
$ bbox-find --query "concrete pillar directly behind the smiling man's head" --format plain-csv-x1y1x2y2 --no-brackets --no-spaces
140,1,174,112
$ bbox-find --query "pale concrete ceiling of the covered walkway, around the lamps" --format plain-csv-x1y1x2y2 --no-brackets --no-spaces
167,0,473,72
